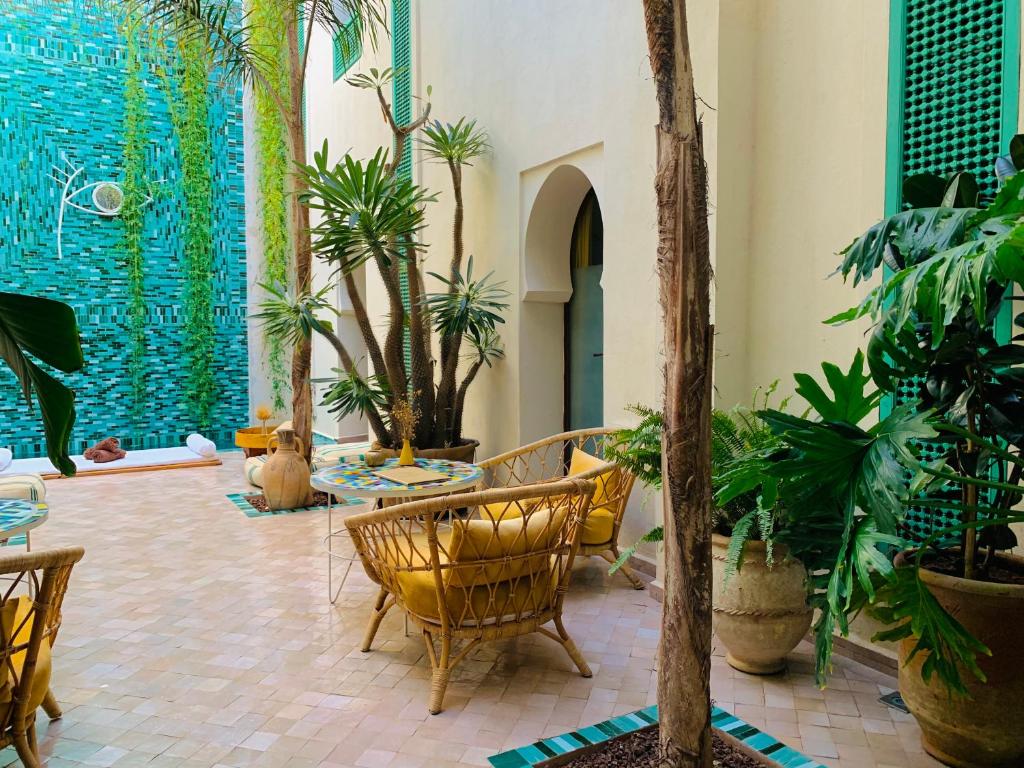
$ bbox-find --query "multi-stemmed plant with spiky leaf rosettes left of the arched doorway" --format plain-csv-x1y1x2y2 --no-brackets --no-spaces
258,69,508,449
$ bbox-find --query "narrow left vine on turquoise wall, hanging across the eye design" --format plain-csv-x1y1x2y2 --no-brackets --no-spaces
121,14,148,429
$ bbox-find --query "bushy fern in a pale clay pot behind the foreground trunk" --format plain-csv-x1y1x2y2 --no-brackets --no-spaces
609,393,811,675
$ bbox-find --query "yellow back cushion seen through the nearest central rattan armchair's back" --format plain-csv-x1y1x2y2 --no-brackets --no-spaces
447,505,568,587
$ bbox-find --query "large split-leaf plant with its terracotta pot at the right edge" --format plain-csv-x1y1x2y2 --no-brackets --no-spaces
761,136,1024,768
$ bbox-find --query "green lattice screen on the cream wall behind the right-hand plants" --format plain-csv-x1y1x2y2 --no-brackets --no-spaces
886,0,1020,538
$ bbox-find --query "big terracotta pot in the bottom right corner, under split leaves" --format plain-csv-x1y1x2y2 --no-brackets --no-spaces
896,553,1024,768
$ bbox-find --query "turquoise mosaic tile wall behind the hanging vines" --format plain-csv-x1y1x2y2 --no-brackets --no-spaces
0,0,249,457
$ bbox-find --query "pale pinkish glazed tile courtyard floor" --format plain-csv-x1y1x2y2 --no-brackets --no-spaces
6,454,939,768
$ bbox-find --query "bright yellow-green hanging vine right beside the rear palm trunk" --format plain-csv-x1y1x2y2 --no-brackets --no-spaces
250,0,289,411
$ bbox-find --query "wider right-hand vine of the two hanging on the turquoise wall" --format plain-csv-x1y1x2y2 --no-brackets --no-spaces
172,37,216,430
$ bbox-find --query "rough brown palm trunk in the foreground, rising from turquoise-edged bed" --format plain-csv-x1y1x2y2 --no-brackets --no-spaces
644,0,712,768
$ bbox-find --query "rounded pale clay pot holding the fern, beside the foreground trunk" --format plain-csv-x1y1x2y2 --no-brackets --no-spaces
712,534,811,675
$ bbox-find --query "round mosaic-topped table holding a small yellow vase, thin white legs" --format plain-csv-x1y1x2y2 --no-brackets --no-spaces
309,459,483,603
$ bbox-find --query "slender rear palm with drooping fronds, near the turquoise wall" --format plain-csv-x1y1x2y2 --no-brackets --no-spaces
136,0,386,458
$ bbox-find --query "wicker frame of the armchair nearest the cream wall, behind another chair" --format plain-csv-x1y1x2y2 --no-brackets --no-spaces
478,434,644,590
